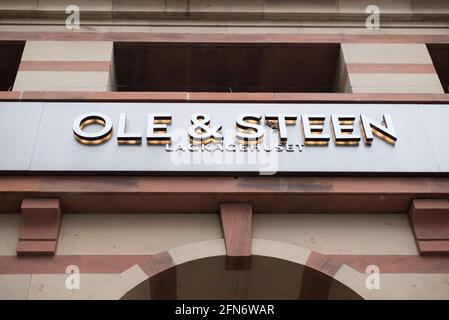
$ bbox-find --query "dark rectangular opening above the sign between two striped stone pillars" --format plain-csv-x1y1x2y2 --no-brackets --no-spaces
114,42,340,92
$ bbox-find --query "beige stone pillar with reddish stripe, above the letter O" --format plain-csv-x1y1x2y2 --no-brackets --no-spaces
13,41,115,91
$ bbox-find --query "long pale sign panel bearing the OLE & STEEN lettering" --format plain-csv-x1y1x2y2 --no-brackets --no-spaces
0,102,449,175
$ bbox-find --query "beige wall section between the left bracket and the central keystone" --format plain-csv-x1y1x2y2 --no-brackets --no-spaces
57,214,222,255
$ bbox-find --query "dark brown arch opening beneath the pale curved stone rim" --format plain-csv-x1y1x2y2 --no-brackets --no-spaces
121,255,362,300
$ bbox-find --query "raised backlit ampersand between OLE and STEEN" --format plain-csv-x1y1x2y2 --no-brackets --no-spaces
189,113,223,144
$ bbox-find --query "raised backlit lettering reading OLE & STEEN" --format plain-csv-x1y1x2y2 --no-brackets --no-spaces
73,112,397,149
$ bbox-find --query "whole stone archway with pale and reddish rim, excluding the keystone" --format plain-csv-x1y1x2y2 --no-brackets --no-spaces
92,239,382,300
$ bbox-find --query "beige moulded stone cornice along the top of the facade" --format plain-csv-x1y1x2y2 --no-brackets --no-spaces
0,0,449,34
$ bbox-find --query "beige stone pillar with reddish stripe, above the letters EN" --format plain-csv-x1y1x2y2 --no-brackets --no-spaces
339,43,444,94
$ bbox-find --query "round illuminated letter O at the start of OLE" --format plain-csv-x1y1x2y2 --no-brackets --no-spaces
73,112,112,144
